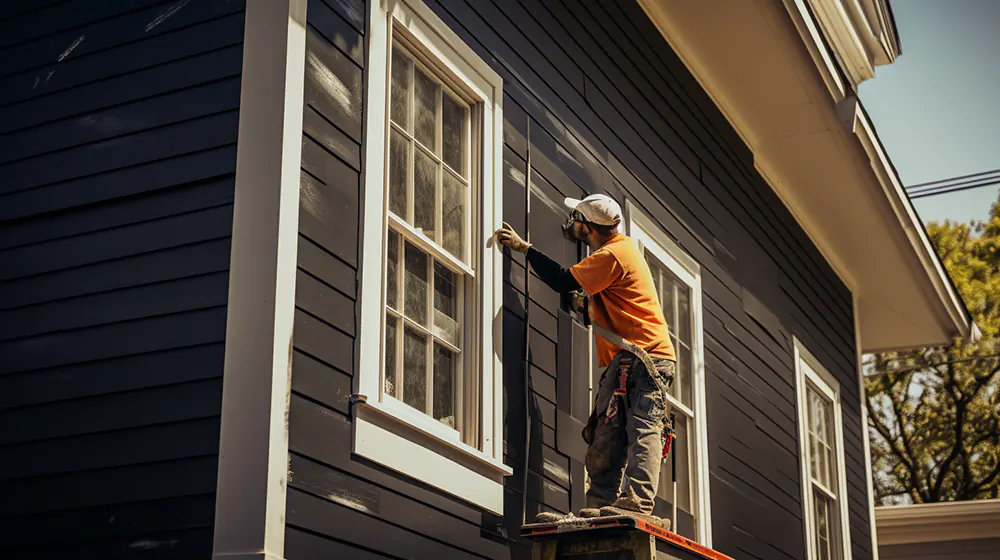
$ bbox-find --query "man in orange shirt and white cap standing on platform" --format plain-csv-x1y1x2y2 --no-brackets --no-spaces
495,194,676,526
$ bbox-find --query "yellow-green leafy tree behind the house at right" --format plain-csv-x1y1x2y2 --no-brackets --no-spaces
865,201,1000,505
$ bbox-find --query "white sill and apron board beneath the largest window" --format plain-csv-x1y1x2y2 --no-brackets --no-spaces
354,405,512,515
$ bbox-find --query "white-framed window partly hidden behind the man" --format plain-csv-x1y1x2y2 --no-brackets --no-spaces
626,203,711,546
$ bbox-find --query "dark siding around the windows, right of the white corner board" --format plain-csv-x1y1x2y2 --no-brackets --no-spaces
286,0,871,560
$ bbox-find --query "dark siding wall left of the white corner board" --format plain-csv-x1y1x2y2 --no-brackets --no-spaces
0,0,243,558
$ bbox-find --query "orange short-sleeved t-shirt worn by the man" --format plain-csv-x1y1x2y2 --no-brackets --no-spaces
569,234,677,367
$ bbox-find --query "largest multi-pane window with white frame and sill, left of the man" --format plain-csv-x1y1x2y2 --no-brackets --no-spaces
354,0,511,513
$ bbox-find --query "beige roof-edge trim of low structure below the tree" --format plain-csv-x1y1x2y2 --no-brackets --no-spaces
875,499,1000,545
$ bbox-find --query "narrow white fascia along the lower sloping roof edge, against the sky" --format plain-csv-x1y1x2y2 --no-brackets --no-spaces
837,100,978,344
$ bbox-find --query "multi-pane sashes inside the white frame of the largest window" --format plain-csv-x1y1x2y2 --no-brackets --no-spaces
383,38,479,447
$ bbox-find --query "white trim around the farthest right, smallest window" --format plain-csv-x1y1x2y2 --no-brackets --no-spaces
795,337,851,560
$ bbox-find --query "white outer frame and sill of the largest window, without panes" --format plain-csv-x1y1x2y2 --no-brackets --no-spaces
353,0,513,514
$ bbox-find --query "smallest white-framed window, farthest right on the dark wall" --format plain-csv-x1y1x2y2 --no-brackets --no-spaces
795,340,850,560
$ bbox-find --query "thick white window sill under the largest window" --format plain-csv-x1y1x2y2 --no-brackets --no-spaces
354,401,514,515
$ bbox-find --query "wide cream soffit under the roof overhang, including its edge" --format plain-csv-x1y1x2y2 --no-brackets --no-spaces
640,0,973,352
